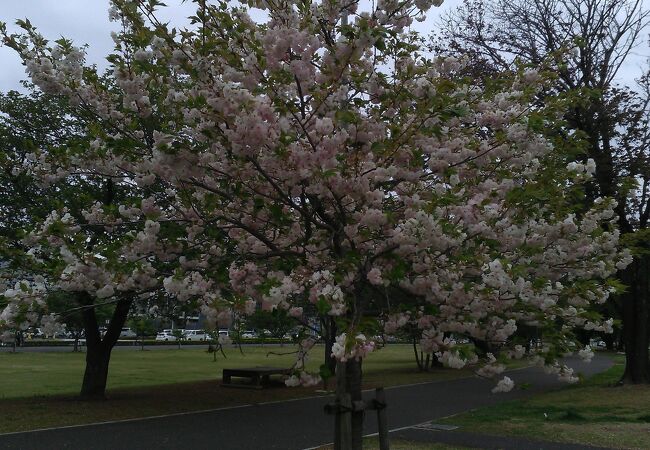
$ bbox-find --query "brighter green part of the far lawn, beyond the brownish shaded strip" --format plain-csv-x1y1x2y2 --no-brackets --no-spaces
0,344,470,399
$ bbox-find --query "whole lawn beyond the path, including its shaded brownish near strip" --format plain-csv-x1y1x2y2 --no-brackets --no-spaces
0,344,471,433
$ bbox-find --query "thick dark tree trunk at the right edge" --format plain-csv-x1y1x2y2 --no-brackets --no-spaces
620,255,650,384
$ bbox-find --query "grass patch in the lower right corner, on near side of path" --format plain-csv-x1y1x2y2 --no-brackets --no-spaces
438,357,650,448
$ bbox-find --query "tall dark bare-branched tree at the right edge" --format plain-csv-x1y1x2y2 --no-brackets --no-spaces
434,0,650,383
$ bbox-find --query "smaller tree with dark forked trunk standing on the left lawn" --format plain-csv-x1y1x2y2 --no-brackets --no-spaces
0,83,190,398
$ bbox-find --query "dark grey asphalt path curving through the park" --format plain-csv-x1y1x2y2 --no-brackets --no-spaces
0,355,612,450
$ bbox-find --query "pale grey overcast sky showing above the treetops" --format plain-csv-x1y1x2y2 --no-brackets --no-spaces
0,0,650,91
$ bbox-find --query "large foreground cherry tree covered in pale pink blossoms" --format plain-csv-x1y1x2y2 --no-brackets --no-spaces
0,0,629,442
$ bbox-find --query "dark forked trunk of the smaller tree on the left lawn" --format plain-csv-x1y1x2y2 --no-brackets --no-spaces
79,293,132,400
